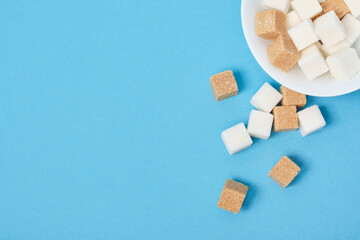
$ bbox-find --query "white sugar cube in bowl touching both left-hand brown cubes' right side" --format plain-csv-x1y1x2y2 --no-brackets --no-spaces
288,19,319,51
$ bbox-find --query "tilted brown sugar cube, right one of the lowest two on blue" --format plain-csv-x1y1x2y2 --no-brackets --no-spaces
268,156,300,188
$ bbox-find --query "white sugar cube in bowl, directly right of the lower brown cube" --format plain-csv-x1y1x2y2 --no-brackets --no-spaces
298,44,329,80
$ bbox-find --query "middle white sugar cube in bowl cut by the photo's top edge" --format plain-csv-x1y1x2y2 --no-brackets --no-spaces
291,0,322,21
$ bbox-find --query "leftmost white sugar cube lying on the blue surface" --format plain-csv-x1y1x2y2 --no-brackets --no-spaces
221,123,253,155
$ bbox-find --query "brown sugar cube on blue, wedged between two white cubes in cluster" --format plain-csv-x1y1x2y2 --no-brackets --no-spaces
273,106,299,132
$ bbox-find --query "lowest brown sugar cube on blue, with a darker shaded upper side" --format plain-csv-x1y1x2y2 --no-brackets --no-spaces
218,179,248,214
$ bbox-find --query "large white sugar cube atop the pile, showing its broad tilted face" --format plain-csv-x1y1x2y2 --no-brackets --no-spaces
314,11,346,47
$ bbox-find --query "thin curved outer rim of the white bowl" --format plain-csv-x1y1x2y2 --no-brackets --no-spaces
241,0,360,97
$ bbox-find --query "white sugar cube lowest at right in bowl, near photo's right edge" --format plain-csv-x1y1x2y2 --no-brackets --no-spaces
326,48,360,80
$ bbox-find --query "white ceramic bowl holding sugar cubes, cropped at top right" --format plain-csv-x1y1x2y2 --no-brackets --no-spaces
241,0,360,97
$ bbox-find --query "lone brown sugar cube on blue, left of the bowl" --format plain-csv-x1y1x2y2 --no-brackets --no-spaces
210,71,239,101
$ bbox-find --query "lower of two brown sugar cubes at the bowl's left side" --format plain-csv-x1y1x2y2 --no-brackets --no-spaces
267,35,300,72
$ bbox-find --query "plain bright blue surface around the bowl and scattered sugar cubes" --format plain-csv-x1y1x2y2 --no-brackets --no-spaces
0,0,360,240
